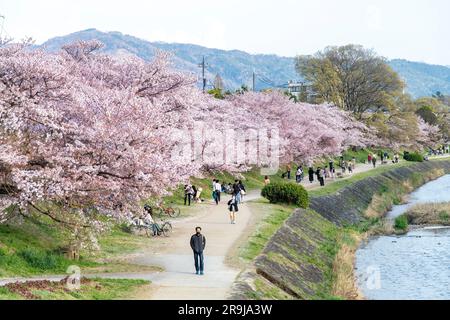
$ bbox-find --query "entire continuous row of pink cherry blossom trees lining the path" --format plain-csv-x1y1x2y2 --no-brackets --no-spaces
0,41,372,240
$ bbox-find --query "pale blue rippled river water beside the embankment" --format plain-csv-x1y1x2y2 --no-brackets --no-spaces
355,175,450,300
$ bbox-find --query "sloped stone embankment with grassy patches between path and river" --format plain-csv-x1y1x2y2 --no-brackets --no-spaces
230,161,450,300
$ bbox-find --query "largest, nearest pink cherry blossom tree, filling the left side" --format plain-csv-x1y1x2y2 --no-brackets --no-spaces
0,41,201,231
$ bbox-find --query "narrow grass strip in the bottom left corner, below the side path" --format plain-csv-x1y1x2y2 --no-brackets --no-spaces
0,278,149,300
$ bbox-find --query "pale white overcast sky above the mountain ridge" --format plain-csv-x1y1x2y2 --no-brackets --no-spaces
0,0,450,65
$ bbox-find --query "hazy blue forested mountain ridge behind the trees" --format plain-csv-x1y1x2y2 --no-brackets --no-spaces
42,29,450,97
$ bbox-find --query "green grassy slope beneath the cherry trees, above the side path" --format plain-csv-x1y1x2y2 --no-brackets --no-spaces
0,217,159,278
